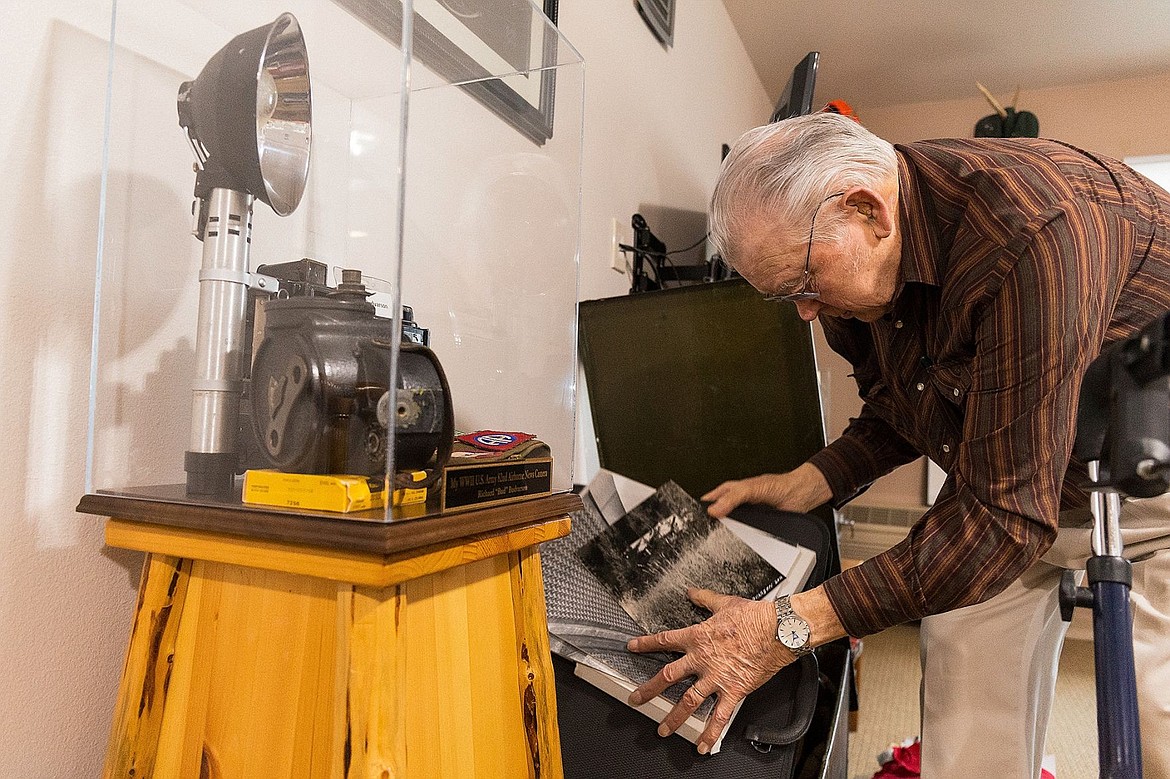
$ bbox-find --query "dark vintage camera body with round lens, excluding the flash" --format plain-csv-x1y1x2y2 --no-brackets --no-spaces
241,258,454,484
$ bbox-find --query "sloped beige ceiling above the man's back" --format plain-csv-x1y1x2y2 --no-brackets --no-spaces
716,0,1170,112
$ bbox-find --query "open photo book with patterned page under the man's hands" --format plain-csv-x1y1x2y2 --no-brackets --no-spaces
541,470,815,753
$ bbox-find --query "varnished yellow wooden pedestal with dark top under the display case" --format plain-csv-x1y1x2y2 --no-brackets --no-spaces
78,488,580,779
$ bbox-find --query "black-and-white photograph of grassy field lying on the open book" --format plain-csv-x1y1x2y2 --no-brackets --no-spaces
577,482,784,633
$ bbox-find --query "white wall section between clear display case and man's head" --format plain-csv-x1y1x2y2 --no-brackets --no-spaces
559,0,771,483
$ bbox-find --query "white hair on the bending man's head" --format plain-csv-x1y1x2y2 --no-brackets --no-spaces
708,112,897,267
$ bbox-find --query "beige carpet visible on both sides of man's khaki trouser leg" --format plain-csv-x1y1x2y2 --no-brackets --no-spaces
849,626,1097,779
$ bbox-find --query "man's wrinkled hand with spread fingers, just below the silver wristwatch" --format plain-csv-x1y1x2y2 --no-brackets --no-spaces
627,588,794,754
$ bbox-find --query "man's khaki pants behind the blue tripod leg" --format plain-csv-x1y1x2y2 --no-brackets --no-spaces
921,494,1170,779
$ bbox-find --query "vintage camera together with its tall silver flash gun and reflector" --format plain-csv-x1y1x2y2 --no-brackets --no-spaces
176,13,454,496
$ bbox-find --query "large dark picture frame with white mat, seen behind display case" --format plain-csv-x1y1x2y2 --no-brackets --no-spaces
333,0,559,146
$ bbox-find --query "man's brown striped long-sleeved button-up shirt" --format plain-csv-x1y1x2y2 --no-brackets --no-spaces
812,138,1170,635
